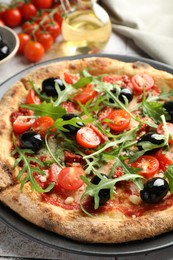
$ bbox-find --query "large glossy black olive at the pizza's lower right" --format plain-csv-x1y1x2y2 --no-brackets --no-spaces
140,177,169,203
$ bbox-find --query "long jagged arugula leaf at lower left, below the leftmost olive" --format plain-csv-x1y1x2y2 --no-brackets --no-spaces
12,136,54,192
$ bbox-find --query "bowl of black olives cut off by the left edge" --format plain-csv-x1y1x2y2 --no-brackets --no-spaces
0,26,19,64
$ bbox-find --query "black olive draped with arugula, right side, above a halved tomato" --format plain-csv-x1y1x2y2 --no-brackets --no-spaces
137,132,164,150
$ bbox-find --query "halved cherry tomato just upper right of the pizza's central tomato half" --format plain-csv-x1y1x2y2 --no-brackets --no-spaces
107,109,130,132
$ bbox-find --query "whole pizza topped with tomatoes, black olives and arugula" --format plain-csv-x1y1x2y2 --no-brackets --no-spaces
0,57,173,243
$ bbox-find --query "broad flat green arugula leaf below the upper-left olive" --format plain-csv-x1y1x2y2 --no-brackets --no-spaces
20,101,66,120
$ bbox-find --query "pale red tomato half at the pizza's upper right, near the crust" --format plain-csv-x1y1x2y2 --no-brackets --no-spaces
131,73,154,93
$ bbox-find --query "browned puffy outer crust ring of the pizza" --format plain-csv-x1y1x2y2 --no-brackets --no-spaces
0,57,173,243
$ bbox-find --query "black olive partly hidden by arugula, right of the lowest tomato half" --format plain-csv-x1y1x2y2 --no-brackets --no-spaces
91,174,110,206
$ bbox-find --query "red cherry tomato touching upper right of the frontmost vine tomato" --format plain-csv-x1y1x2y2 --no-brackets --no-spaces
35,31,54,51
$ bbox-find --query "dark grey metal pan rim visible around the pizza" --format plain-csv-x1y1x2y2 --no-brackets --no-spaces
0,54,173,257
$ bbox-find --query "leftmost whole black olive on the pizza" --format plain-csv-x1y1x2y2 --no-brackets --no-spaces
20,131,44,152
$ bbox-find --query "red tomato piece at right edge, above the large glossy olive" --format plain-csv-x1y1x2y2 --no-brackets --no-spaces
155,149,173,172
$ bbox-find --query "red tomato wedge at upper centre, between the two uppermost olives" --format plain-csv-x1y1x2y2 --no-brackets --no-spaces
73,84,97,104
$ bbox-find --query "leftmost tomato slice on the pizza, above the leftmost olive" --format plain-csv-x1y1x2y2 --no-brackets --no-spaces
13,116,35,134
